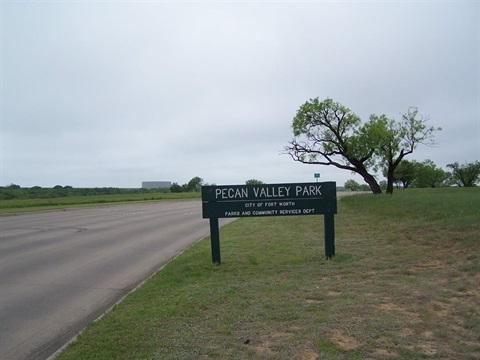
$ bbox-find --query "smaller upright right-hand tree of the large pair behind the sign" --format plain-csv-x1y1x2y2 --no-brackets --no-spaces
372,107,441,194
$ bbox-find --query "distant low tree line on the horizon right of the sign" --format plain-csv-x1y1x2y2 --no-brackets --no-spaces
344,159,480,191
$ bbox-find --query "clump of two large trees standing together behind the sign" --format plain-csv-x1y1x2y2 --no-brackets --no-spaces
284,98,441,194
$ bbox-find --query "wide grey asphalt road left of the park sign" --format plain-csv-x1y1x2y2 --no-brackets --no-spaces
0,201,232,360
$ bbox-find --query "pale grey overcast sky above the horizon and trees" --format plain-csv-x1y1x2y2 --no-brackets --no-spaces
0,0,480,188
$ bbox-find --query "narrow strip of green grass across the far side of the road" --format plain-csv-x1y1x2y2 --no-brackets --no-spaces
0,192,201,213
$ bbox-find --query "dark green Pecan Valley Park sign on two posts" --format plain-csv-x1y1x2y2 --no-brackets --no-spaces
202,181,337,264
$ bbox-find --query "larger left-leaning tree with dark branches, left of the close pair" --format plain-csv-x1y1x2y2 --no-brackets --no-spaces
284,98,382,194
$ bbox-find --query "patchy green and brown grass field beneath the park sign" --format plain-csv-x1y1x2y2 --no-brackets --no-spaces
58,188,480,360
